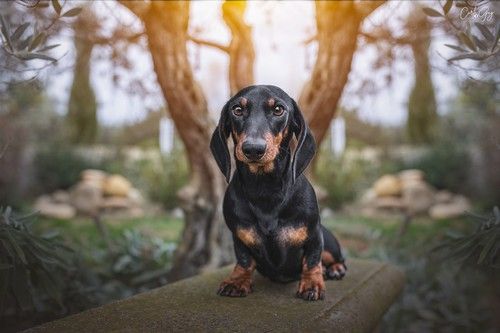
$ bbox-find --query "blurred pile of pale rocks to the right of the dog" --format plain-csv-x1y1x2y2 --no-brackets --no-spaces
356,170,470,219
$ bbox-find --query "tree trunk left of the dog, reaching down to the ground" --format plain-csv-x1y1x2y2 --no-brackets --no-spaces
142,1,232,281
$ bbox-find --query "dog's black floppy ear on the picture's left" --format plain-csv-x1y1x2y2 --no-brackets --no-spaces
210,104,231,183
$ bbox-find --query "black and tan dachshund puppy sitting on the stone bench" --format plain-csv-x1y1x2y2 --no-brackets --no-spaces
210,86,346,300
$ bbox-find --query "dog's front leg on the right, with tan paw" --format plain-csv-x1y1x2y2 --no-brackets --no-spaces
297,224,325,301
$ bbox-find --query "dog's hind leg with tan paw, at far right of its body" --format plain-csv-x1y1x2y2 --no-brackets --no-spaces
321,226,347,280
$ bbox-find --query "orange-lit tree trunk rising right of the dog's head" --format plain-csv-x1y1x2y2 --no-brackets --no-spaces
299,1,383,146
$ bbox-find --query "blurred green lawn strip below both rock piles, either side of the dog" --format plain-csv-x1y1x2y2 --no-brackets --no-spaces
33,215,471,257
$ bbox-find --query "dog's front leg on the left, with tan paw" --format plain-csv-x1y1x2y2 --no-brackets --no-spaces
217,237,255,297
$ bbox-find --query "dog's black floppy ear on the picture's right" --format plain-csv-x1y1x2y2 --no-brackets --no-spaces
292,100,316,182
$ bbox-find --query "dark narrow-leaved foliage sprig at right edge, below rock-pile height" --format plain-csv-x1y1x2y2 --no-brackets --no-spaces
435,207,500,269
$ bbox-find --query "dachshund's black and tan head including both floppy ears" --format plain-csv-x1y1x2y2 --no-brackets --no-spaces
210,86,316,182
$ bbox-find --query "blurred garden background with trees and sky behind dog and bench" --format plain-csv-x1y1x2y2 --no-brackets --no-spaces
0,0,500,332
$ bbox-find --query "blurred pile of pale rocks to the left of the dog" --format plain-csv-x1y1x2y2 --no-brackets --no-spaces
35,169,145,219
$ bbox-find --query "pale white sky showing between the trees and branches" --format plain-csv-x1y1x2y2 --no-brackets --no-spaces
49,1,457,126
